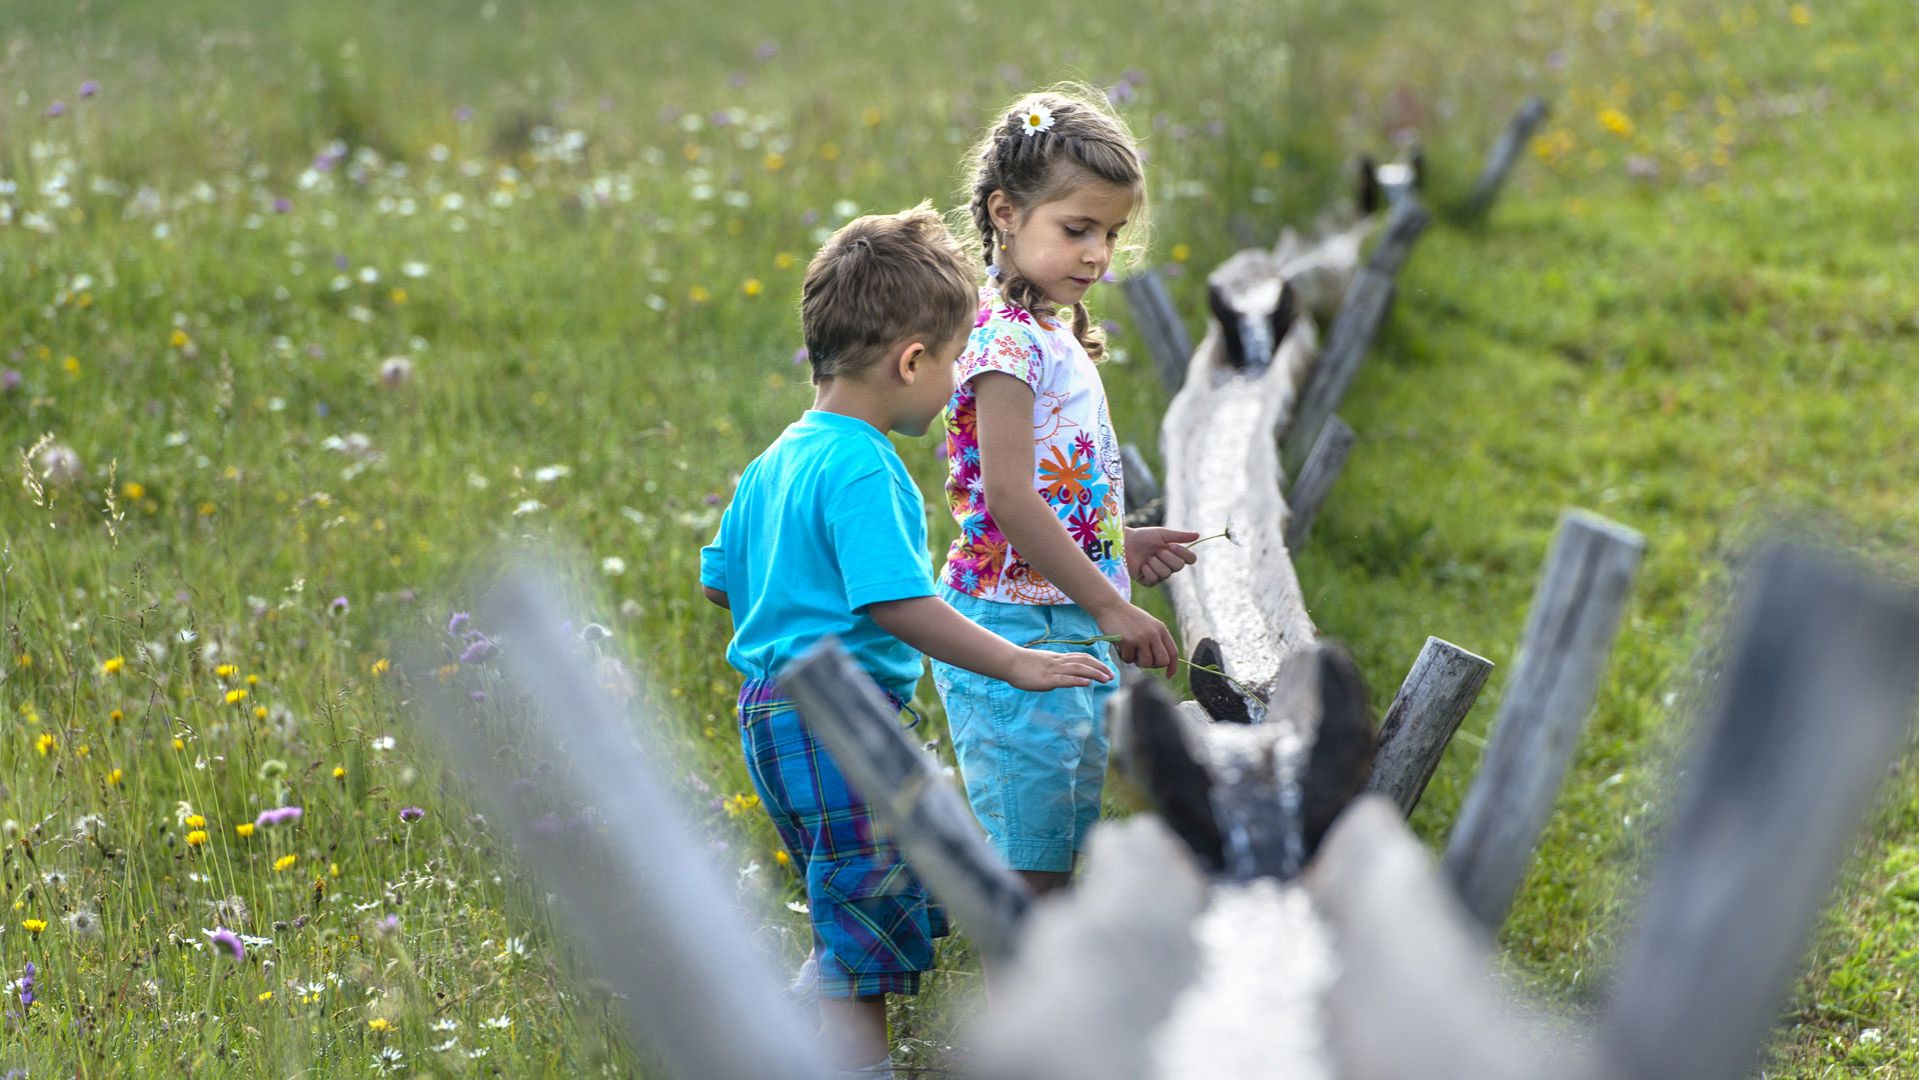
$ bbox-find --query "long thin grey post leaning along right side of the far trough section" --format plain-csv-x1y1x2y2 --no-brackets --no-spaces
1280,200,1432,472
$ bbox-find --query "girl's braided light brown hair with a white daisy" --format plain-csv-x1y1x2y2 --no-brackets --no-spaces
963,82,1148,361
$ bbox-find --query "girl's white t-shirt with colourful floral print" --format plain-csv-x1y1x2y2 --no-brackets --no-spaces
940,286,1132,604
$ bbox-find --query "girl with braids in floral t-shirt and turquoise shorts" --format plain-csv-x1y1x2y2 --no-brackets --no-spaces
933,88,1199,892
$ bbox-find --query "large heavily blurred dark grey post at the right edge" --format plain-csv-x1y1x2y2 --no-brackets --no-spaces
1602,545,1919,1080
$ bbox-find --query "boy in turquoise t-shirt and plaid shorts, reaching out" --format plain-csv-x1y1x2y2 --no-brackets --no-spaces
700,203,1113,1076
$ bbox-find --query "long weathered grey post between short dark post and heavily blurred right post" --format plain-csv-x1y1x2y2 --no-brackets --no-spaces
1445,510,1645,928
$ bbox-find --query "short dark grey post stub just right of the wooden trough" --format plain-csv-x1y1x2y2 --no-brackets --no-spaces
1366,637,1493,817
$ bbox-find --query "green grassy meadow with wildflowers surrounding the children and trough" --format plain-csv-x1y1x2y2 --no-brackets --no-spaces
0,0,1919,1076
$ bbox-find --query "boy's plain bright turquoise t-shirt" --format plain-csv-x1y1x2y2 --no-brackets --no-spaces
700,409,933,698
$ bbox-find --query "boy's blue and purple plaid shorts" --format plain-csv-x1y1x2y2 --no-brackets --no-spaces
739,679,948,998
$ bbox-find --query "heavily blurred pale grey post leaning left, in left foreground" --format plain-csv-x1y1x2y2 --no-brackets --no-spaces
409,572,839,1080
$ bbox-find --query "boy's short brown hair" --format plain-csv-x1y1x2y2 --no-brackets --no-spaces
800,203,979,384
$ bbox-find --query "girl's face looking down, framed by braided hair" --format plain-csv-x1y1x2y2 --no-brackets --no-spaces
986,178,1136,307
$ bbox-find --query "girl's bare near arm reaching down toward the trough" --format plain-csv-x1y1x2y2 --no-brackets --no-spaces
973,372,1180,679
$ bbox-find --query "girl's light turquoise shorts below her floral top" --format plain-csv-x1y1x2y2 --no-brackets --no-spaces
933,585,1119,871
